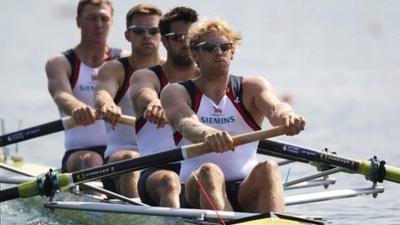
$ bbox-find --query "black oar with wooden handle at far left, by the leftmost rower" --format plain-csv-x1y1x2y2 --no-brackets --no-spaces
0,115,135,147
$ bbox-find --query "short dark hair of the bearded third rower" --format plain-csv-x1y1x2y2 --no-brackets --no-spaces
158,6,198,35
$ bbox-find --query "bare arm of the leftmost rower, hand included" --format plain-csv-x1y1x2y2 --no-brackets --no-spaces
46,55,96,125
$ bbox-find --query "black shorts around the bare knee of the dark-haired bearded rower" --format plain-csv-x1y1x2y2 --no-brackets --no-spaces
138,163,181,206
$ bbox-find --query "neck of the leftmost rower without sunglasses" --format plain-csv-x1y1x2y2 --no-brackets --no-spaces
75,42,109,68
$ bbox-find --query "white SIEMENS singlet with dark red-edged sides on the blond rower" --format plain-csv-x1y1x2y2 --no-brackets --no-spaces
175,75,260,182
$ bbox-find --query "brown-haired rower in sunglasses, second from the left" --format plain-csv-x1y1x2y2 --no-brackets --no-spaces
95,4,162,198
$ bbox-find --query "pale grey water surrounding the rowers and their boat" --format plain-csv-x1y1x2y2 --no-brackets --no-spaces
0,0,400,225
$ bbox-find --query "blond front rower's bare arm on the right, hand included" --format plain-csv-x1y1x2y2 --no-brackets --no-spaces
244,77,305,135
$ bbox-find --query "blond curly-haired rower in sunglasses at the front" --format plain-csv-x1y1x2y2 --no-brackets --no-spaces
161,19,305,212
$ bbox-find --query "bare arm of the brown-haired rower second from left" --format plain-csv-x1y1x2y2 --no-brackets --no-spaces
94,60,124,127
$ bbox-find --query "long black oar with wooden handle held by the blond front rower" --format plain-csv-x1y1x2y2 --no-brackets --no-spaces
0,126,286,202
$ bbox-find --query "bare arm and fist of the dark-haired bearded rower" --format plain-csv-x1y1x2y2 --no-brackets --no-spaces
130,69,166,127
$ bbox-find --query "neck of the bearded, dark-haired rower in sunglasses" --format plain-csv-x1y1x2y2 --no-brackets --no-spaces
162,60,199,83
